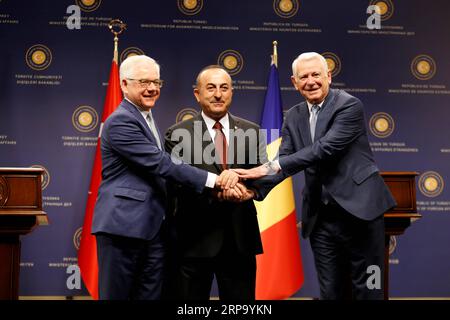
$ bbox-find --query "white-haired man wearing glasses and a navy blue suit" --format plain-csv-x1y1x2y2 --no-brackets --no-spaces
92,55,239,300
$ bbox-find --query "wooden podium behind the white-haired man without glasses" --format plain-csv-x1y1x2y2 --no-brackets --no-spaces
381,172,422,300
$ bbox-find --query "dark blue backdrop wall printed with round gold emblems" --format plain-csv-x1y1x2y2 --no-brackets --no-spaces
0,0,450,297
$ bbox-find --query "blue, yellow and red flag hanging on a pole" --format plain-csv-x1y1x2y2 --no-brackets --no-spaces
255,43,303,300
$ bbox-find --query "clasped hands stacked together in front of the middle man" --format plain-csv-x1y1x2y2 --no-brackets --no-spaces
213,170,255,202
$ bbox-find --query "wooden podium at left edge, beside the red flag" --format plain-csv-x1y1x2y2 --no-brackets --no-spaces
0,168,48,300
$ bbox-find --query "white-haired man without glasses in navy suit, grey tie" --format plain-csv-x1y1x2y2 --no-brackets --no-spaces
236,52,395,299
